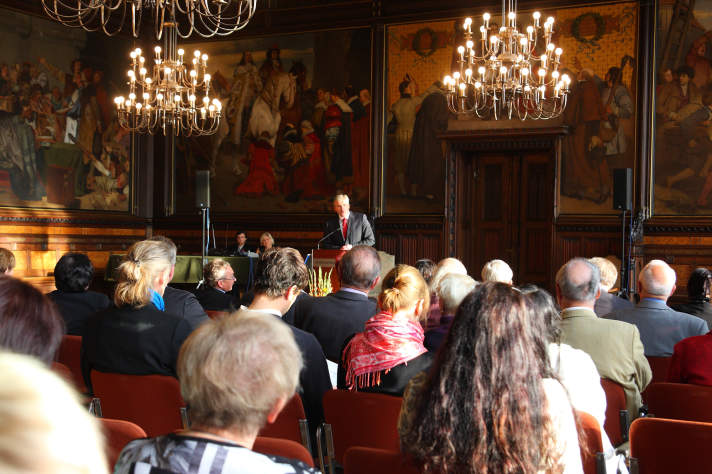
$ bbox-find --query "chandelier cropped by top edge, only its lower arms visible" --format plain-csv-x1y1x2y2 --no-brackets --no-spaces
42,0,257,40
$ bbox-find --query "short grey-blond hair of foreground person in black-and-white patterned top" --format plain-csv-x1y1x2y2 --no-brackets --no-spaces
178,310,303,435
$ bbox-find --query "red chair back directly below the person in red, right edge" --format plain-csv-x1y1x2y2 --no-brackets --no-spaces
645,383,712,423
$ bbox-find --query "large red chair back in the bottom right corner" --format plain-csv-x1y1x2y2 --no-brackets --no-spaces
630,418,712,474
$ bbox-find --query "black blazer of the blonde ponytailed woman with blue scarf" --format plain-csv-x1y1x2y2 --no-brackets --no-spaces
81,303,193,387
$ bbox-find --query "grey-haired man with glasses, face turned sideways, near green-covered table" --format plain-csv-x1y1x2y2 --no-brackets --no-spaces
196,258,240,311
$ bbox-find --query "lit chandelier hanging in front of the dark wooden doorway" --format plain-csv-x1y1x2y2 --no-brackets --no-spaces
443,0,571,120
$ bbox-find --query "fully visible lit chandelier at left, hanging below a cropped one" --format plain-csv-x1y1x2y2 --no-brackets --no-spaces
114,22,222,136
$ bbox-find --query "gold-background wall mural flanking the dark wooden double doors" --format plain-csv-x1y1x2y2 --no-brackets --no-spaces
384,3,638,214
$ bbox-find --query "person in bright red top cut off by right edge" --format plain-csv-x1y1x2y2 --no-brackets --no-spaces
667,332,712,386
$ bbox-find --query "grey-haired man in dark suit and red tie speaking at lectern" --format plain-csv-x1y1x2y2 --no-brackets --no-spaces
321,194,376,250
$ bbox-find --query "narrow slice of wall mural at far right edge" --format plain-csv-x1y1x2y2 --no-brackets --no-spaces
653,0,712,215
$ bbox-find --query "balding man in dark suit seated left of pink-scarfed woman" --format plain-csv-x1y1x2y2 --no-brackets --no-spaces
294,245,381,364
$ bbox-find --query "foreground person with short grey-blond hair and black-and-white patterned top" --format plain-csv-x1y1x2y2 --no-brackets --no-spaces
114,311,317,474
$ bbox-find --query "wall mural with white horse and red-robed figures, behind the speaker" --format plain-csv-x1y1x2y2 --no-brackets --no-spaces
176,29,371,212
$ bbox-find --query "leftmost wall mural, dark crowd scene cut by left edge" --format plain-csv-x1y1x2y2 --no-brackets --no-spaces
0,9,131,211
